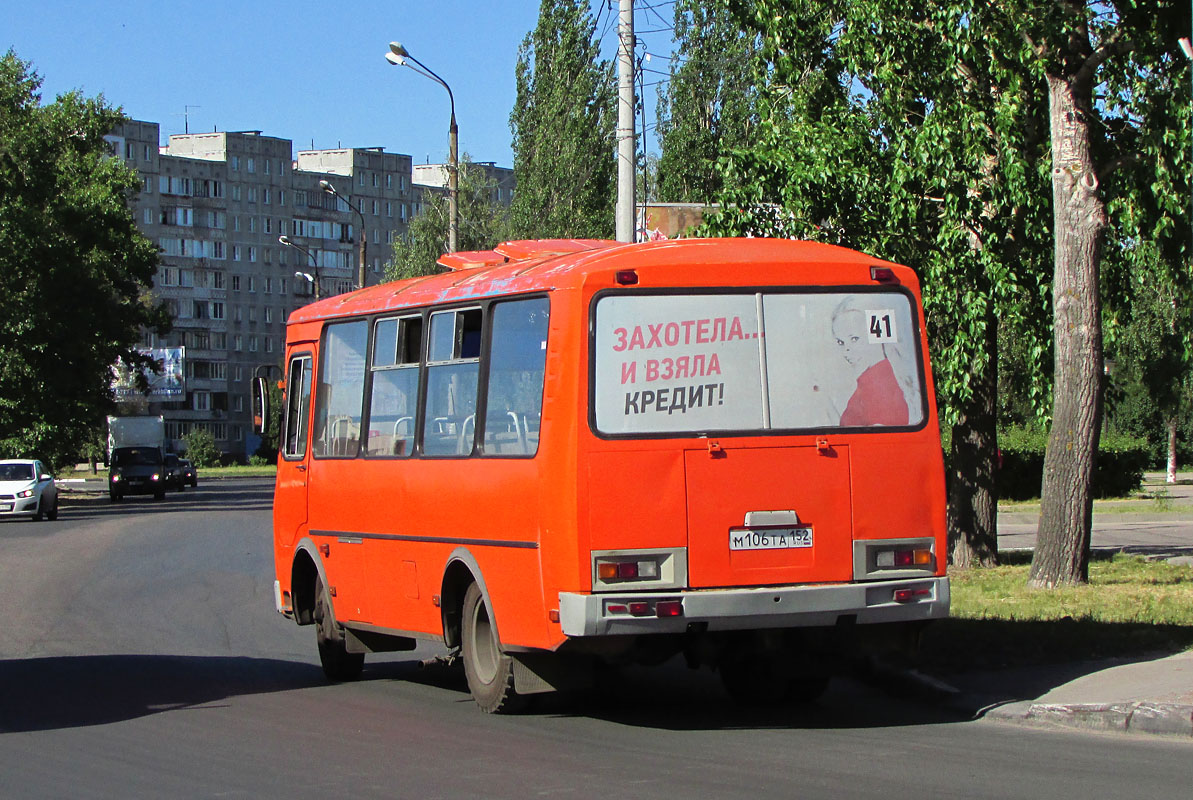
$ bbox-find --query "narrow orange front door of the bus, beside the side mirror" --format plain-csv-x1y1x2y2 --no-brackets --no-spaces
273,352,311,553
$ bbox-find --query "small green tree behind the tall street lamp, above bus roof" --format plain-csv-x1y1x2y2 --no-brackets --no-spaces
385,154,507,280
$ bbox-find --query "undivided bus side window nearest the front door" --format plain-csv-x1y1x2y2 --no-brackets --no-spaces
313,320,369,457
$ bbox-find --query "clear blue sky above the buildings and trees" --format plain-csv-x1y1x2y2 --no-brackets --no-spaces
0,0,673,167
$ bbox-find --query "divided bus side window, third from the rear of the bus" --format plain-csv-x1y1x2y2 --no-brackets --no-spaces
365,316,422,455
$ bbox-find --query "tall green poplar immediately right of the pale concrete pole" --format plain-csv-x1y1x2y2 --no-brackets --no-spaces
657,0,758,203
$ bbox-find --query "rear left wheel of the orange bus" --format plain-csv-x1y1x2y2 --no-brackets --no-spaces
460,583,527,714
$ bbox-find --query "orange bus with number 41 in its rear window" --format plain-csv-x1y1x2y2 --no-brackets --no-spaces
263,238,948,712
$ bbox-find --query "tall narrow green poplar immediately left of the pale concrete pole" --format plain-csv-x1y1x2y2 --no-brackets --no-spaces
509,0,617,238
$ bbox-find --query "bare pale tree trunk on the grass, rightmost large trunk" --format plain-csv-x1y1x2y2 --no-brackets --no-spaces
1028,74,1106,588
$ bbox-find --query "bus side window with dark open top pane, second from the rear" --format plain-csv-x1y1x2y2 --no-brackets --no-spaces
422,309,482,455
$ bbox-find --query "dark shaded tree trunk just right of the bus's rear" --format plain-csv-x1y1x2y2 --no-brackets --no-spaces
947,304,999,569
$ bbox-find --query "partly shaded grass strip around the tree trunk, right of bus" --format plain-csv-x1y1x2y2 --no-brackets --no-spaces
921,556,1193,672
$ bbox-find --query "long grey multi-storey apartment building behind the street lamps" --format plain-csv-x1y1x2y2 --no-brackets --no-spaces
107,120,416,459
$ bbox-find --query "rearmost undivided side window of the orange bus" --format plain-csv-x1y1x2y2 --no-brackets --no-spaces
484,297,550,455
